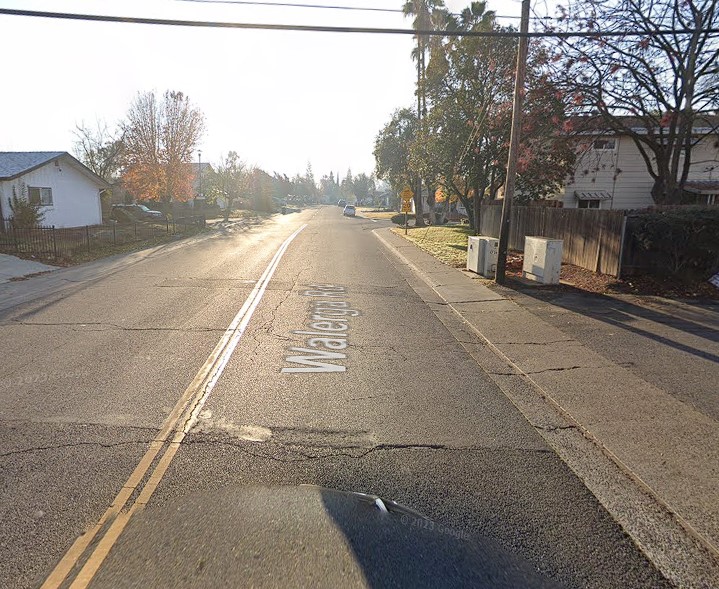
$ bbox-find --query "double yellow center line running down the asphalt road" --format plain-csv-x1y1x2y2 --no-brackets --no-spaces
41,224,307,589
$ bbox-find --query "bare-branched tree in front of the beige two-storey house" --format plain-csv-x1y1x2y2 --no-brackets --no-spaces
553,0,719,204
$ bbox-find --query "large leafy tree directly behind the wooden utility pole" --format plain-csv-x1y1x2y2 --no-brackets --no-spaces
410,2,574,229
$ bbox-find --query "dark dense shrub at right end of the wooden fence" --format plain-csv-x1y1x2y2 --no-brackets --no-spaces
631,207,719,277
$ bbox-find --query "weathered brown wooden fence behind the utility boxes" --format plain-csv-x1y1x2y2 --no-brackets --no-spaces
479,205,625,276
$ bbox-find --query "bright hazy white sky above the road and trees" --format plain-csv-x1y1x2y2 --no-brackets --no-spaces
0,0,521,180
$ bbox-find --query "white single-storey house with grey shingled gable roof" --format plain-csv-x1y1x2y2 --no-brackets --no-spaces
0,151,109,227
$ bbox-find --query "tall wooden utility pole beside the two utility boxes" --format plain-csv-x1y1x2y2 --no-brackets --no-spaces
495,0,529,284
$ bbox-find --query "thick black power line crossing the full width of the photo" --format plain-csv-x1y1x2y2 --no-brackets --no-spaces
0,8,719,39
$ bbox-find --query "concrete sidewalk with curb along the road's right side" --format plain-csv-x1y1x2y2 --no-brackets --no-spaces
375,228,719,587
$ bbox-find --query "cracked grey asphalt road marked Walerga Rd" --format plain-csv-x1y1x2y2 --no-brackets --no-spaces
0,207,670,588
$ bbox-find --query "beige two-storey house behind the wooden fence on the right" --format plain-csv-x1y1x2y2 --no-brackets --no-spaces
551,117,719,209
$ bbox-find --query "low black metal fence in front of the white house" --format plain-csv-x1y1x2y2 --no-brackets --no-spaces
0,216,205,261
